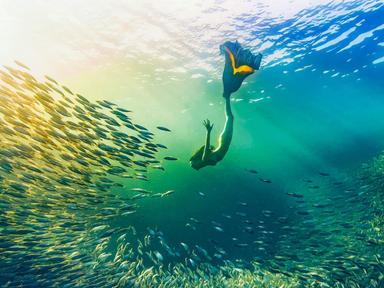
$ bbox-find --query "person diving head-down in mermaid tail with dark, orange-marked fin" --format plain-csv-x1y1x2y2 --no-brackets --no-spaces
190,41,262,170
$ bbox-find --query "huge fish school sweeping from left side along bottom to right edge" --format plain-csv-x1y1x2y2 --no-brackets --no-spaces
0,62,384,288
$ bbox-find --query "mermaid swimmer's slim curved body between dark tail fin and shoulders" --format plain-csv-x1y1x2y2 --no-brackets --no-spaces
212,95,233,161
